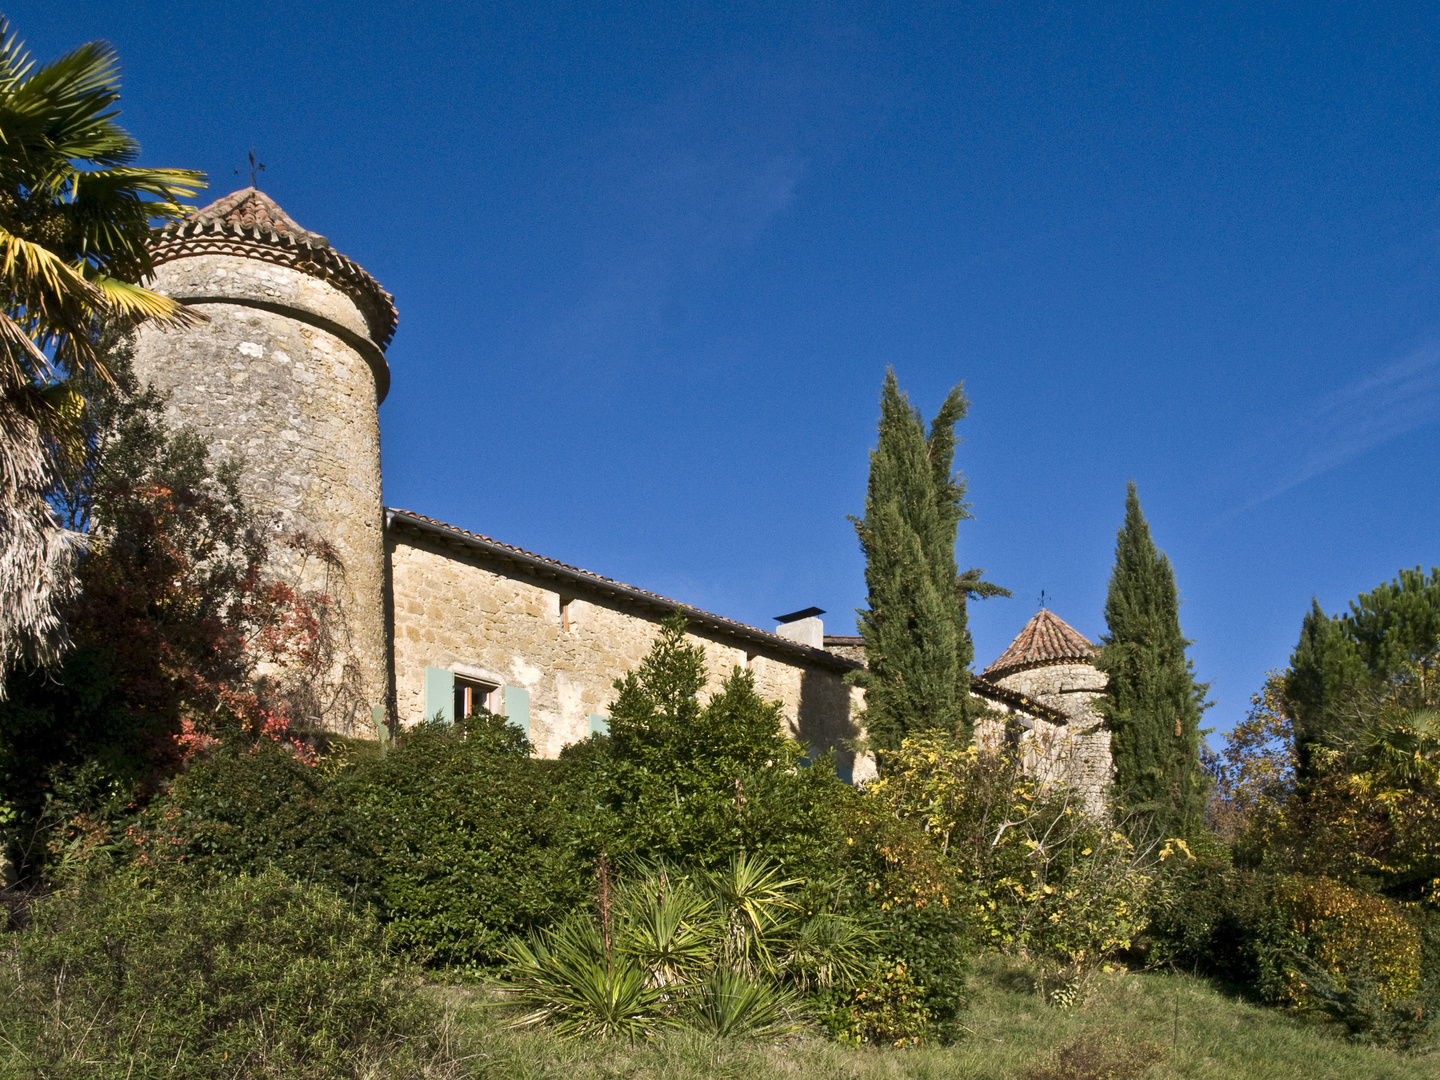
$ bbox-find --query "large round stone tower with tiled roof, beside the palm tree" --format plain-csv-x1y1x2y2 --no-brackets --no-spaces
135,187,396,734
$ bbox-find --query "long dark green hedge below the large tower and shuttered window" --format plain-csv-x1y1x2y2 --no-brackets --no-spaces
147,714,590,966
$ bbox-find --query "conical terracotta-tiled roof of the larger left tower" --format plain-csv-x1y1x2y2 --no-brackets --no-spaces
150,187,399,348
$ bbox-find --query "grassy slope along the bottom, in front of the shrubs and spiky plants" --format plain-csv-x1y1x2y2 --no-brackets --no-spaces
445,966,1440,1080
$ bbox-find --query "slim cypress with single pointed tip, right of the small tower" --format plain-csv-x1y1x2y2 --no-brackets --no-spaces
1097,484,1210,835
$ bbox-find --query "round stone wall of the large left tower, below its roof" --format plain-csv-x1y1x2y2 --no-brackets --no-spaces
135,255,389,734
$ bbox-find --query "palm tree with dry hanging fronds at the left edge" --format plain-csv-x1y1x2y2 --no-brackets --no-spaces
0,16,204,694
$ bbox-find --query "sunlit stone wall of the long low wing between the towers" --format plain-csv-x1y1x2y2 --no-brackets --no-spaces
387,530,874,782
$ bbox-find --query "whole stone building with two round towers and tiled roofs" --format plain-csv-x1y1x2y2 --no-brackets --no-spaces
135,187,1109,801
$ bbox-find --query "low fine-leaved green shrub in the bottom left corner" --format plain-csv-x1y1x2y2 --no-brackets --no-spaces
0,870,445,1080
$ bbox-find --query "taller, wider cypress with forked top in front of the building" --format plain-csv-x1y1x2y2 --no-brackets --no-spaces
851,370,973,749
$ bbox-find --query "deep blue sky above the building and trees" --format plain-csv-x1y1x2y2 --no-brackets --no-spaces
19,0,1440,729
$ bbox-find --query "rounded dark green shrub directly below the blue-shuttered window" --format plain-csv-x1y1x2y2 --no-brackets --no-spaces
337,713,590,968
